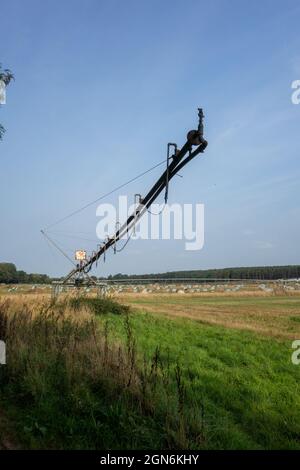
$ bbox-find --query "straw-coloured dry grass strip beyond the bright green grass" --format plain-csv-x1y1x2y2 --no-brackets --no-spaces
119,292,300,339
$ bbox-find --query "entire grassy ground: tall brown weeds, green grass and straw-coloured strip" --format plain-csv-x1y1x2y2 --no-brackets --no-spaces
0,292,300,449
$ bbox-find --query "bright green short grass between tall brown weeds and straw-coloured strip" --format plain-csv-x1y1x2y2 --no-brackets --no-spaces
93,302,300,449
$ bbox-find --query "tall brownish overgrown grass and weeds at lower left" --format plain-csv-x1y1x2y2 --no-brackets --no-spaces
0,300,167,449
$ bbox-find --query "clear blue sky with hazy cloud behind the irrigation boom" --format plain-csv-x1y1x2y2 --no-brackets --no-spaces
0,0,300,275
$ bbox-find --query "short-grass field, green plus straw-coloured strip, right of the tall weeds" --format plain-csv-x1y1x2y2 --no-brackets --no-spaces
97,296,300,448
